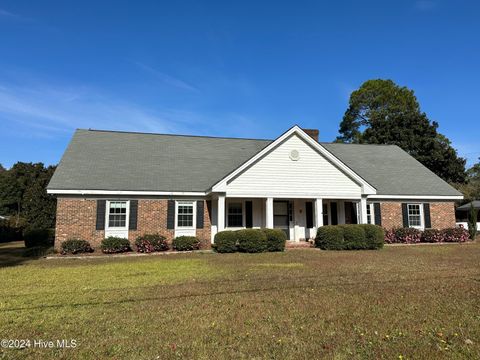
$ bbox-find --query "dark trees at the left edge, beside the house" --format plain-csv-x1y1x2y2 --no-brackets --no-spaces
0,162,56,230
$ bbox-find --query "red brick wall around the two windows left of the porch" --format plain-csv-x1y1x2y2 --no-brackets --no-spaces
55,198,211,248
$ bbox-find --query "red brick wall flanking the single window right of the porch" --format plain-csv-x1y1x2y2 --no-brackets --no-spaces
380,201,455,229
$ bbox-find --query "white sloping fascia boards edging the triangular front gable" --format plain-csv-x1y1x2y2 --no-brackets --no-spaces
212,125,377,195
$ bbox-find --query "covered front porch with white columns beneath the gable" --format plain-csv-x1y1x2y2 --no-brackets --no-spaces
211,194,373,242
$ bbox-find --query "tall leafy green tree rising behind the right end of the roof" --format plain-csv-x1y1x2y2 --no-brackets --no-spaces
336,79,465,183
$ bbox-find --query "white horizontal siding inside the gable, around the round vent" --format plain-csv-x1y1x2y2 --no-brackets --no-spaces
227,134,361,198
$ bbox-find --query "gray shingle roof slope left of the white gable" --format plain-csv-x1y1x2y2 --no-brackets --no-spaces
48,130,271,191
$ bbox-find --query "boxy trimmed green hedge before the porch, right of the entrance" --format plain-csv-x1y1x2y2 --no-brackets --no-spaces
315,224,385,250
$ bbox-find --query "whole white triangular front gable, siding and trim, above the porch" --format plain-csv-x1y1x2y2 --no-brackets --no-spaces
212,127,375,198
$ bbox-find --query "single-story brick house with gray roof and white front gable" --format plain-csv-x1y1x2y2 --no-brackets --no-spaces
48,126,463,246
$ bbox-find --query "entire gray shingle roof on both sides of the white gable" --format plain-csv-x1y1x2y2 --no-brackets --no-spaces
48,130,461,195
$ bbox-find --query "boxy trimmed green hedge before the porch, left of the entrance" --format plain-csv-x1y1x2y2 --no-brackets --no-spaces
212,229,287,253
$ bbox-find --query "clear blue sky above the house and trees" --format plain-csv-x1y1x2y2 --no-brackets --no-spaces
0,0,480,167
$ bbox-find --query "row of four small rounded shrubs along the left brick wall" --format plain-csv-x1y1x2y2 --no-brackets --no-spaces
61,234,200,255
